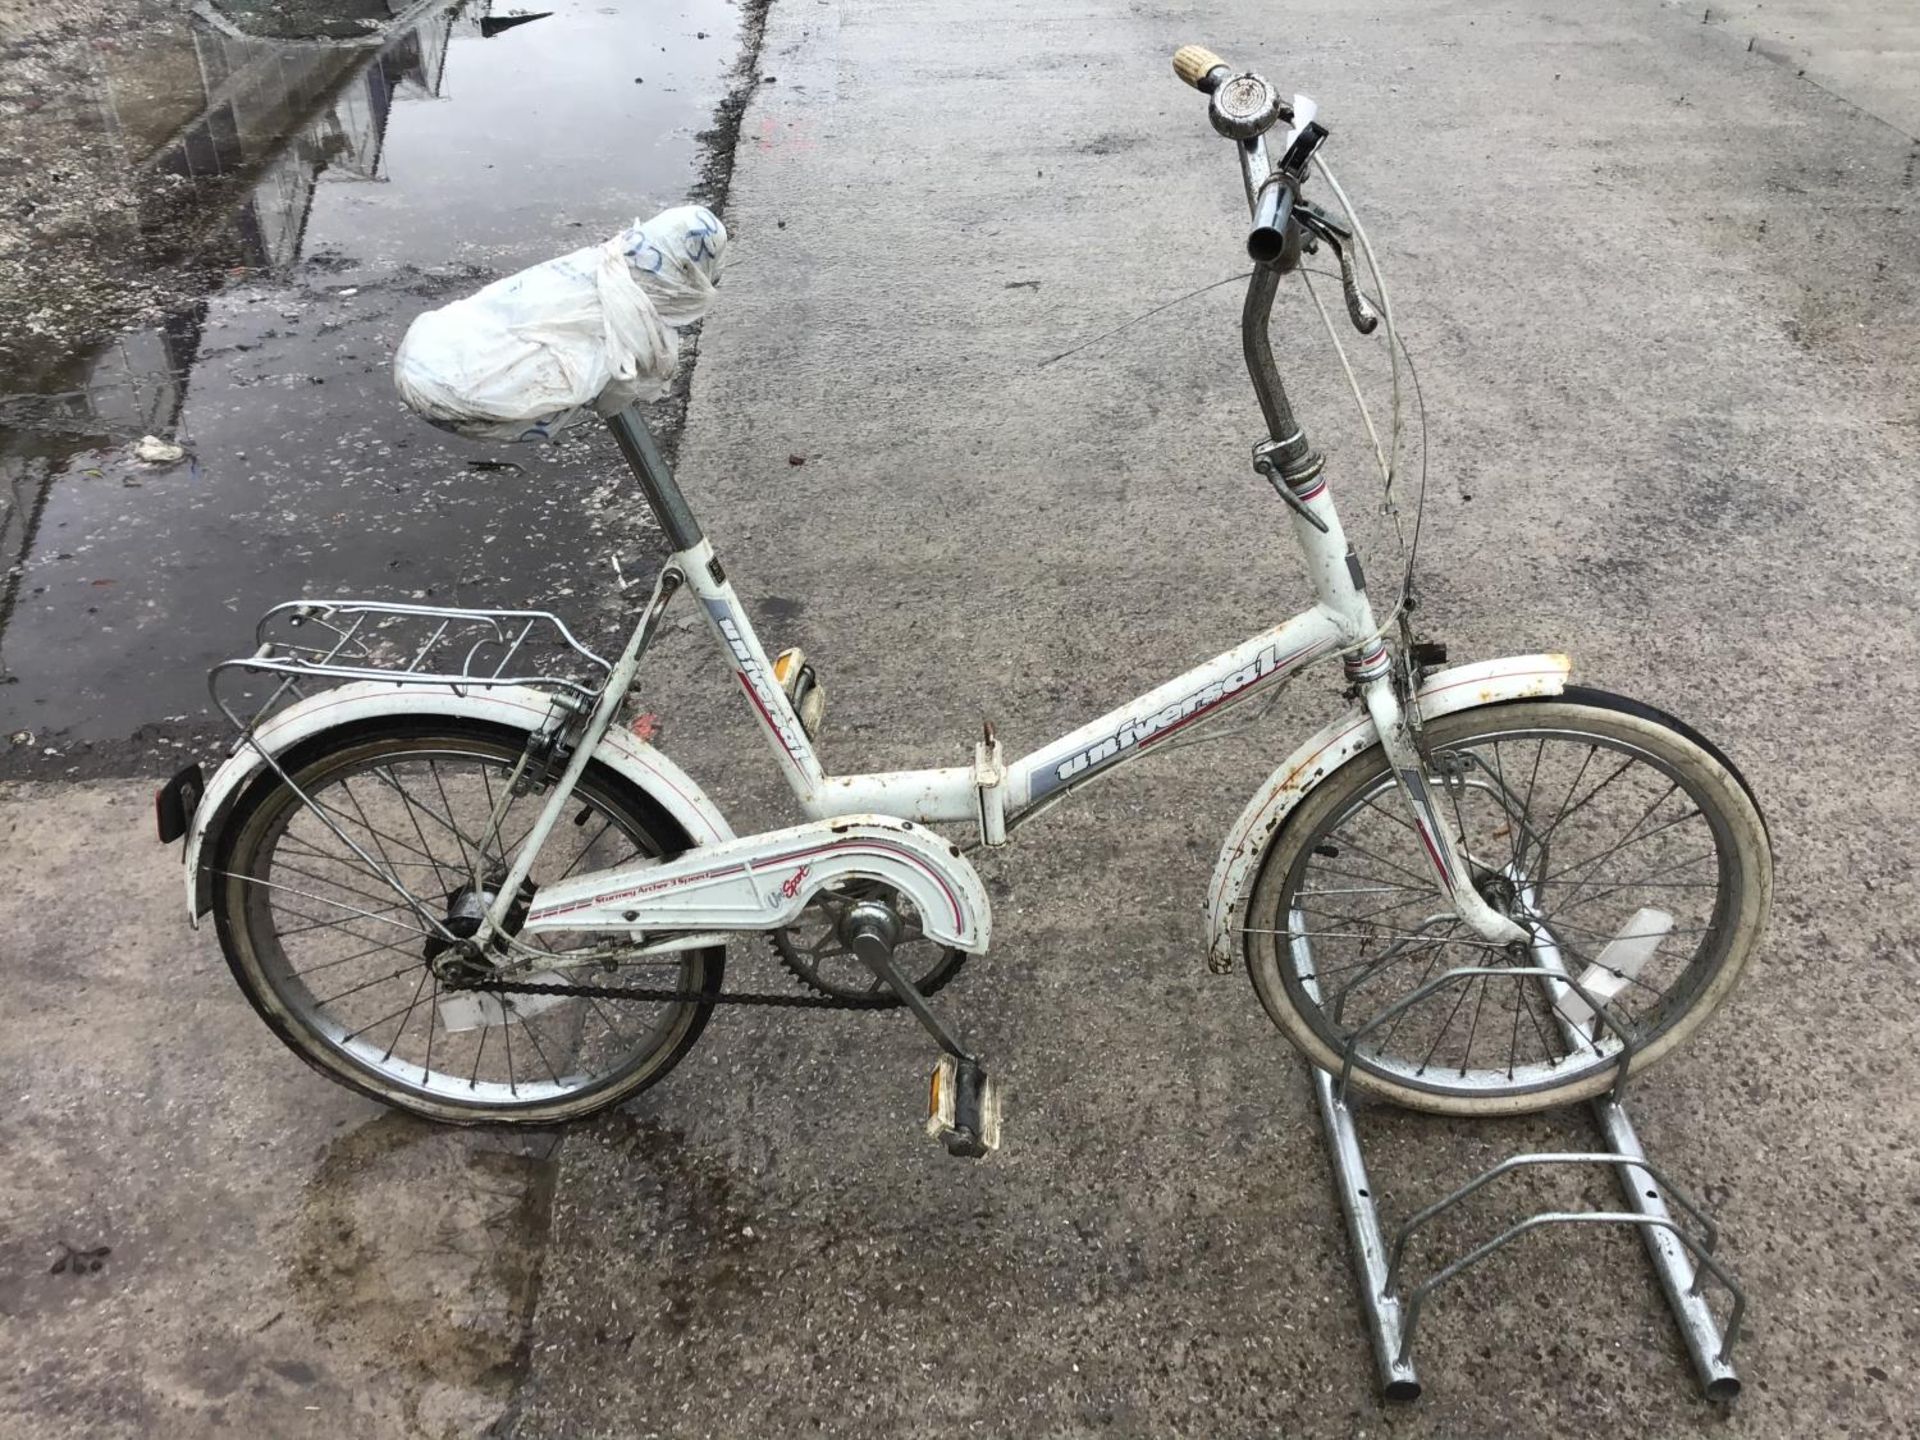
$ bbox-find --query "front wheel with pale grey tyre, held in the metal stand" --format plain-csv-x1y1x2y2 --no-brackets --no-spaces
1244,687,1772,1116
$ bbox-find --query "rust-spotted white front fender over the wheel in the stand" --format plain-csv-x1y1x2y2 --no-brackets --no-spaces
1206,655,1572,973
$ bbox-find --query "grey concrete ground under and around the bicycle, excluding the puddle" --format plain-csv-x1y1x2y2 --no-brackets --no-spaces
0,0,1920,1436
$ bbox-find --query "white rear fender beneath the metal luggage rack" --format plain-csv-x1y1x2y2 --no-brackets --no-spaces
186,680,733,927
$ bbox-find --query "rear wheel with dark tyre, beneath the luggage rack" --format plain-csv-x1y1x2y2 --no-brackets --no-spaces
213,720,726,1125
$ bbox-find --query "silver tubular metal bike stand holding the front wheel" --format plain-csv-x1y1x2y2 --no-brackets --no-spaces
1313,963,1747,1402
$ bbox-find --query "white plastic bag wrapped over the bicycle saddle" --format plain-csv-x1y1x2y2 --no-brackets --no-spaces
394,205,726,440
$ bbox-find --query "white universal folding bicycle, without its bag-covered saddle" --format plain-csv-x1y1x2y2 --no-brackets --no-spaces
159,48,1772,1156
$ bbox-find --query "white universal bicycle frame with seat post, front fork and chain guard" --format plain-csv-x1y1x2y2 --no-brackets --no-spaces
478,391,1524,948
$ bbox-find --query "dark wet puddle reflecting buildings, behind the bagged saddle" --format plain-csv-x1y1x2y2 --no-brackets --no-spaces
0,0,739,760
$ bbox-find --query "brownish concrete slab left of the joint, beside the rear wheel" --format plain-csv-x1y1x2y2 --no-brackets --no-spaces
0,785,557,1440
